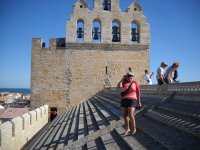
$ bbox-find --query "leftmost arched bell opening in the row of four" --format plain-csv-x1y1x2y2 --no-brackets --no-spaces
76,19,84,42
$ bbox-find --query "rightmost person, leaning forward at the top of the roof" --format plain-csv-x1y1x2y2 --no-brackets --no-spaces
164,62,180,83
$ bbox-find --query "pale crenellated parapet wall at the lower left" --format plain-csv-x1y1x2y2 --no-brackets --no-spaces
0,105,48,150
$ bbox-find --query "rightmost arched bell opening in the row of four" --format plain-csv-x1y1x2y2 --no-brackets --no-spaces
131,22,140,44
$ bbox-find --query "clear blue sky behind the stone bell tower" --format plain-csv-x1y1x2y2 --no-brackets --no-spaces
0,0,200,88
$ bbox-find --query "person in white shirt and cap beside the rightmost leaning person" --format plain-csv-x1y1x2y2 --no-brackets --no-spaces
156,62,167,85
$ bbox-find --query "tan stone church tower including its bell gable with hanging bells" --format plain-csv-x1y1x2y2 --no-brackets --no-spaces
31,0,150,110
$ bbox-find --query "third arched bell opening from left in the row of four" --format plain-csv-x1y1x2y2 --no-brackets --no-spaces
112,20,121,42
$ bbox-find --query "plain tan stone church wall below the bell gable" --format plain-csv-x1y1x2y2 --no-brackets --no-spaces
31,39,149,110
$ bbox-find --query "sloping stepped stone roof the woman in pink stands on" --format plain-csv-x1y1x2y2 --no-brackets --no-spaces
24,82,200,150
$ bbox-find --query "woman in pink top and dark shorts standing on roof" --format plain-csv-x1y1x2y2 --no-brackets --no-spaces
117,71,142,135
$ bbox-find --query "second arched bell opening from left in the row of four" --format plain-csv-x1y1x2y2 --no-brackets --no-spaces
92,20,101,42
